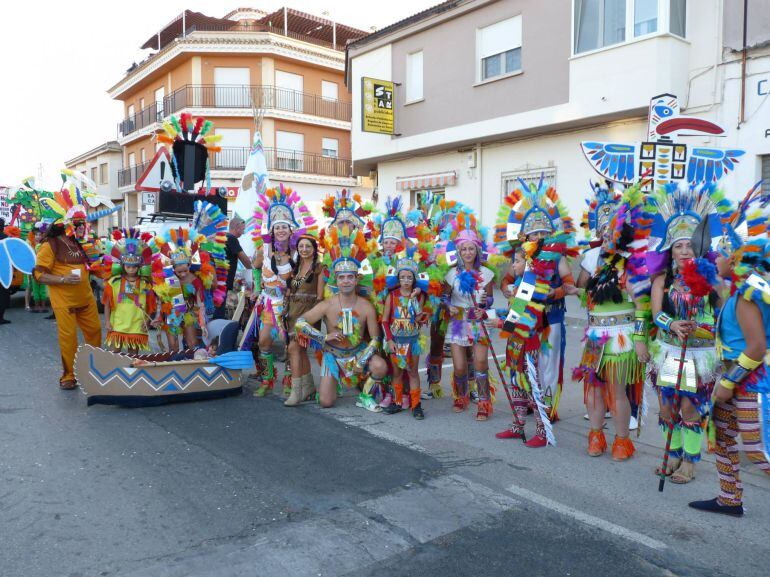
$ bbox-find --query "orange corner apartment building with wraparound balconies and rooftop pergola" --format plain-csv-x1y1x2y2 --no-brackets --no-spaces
109,8,365,223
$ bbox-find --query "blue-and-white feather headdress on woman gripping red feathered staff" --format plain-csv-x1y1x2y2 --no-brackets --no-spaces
649,182,720,252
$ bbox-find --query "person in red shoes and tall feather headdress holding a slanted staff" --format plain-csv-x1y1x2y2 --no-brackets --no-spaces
495,177,578,447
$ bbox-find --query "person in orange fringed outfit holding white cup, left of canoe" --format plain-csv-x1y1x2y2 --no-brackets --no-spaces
34,171,115,390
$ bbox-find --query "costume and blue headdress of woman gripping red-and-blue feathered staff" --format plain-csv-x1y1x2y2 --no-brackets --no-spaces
650,183,719,463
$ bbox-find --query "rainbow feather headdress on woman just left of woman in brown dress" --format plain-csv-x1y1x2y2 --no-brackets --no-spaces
251,184,318,249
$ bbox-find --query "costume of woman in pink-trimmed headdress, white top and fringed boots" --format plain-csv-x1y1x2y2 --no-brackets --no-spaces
438,208,495,420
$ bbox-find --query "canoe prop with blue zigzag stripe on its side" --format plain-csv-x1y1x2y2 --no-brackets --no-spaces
75,345,248,407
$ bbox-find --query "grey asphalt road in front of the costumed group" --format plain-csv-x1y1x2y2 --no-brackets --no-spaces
0,300,770,577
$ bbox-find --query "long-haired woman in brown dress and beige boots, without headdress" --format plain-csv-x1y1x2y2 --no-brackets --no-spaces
283,234,325,407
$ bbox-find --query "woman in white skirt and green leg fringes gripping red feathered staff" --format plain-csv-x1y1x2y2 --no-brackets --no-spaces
650,183,720,484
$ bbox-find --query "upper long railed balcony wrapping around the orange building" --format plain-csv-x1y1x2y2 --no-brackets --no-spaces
118,84,351,138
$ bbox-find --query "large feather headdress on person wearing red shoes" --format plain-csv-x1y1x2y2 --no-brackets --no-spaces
494,175,575,256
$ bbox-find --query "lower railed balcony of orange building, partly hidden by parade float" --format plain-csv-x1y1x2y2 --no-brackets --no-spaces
118,147,353,187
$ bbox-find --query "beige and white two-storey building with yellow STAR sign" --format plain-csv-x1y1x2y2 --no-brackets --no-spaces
346,0,770,224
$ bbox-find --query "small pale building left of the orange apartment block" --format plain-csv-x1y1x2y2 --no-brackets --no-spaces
64,140,126,236
